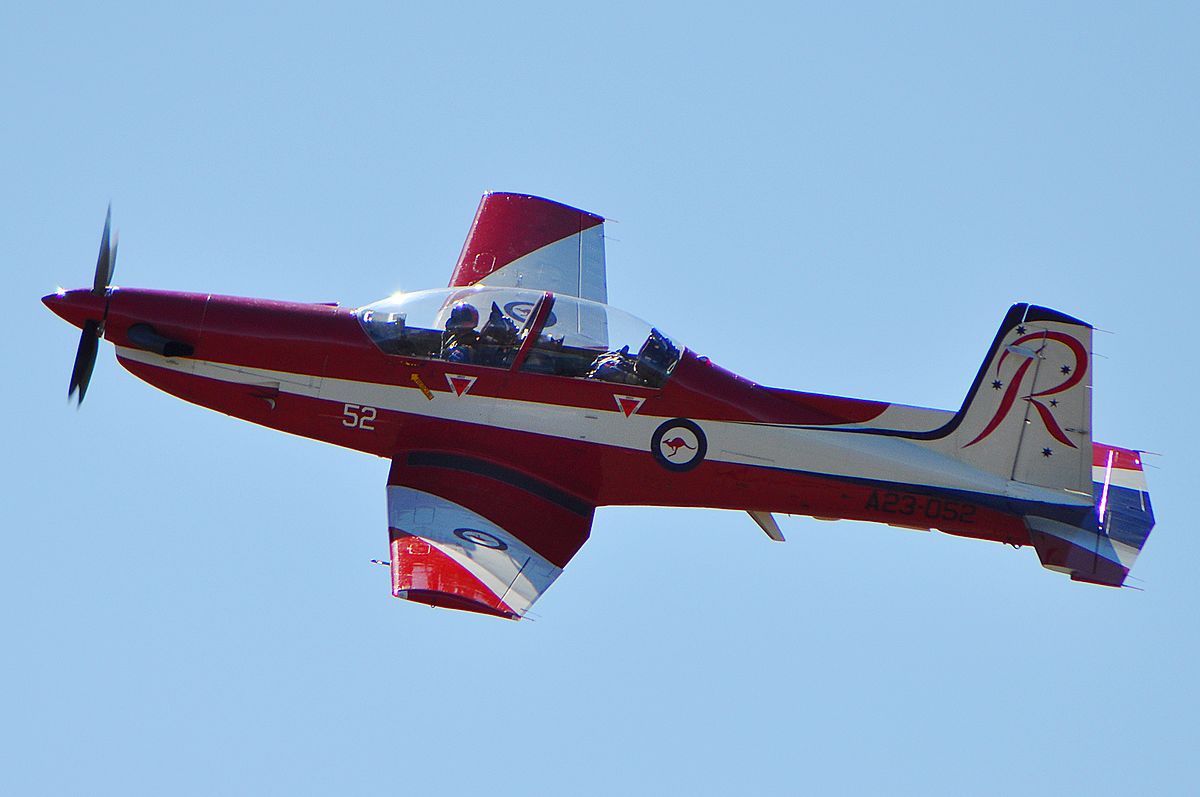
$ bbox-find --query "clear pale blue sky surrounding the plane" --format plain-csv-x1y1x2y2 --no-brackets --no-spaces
0,4,1200,795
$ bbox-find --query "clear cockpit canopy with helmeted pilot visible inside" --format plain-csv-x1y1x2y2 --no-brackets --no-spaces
358,286,682,388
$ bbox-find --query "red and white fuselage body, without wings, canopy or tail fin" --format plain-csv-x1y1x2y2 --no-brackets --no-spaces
44,288,1091,554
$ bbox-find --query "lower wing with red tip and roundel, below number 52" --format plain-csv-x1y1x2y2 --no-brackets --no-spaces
388,451,595,619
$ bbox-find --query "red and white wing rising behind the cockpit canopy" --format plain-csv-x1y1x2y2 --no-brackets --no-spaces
450,193,608,304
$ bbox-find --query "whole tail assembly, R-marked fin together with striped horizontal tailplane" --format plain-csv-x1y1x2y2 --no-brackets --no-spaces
935,304,1154,587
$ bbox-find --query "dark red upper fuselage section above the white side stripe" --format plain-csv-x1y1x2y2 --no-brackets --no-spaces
104,288,888,425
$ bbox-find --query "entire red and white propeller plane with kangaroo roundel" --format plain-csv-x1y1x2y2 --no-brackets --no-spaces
42,193,1154,619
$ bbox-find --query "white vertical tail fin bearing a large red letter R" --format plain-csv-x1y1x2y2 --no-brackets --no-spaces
938,304,1092,495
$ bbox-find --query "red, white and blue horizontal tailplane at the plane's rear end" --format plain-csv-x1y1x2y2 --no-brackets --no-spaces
1025,443,1154,587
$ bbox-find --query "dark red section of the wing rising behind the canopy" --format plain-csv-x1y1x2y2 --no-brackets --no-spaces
450,193,604,288
